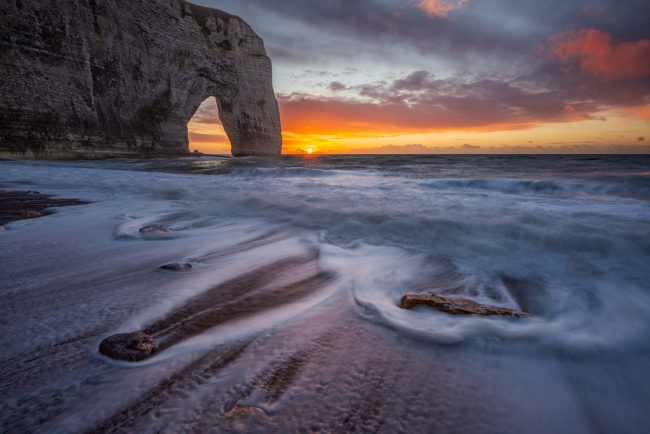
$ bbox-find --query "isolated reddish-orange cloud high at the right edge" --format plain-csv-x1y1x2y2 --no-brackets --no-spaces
549,29,650,79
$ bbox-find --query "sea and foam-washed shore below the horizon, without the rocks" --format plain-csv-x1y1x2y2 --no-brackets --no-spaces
0,155,650,433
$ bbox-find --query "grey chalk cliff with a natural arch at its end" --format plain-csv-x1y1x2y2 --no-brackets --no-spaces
0,0,282,158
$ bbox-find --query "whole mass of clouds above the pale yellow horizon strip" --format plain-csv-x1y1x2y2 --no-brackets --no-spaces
194,0,650,134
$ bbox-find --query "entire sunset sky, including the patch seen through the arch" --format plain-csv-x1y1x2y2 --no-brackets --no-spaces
190,0,650,154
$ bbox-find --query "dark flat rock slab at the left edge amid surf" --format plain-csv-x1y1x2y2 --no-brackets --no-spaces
0,190,88,225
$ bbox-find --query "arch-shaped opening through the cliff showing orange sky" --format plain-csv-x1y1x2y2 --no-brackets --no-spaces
187,96,231,154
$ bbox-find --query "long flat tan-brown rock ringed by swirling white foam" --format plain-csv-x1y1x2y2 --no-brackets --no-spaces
400,295,530,318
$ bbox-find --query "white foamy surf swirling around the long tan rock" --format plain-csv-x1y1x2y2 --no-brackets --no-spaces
339,246,650,355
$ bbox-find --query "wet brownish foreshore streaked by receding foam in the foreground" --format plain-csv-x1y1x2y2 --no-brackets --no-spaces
0,215,504,432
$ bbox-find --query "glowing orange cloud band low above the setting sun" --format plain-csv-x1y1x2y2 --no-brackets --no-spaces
278,90,595,145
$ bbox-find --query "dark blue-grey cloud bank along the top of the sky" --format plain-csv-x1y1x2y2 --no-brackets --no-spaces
200,0,650,67
